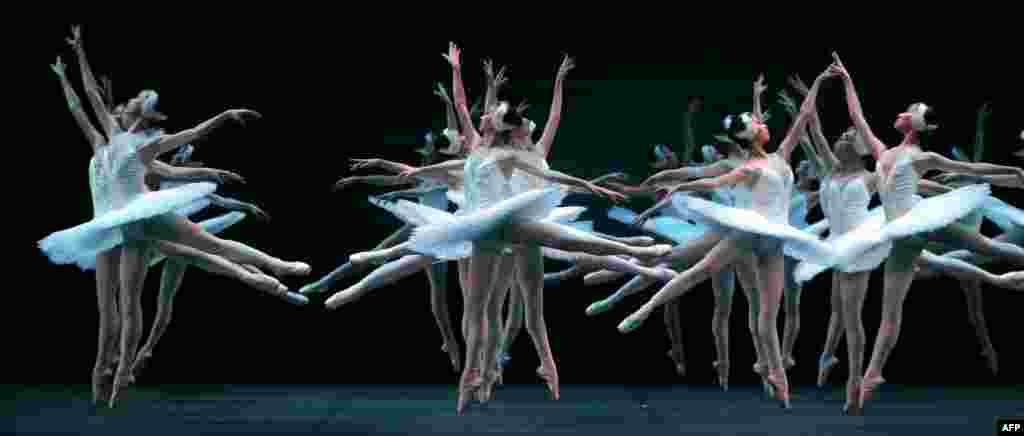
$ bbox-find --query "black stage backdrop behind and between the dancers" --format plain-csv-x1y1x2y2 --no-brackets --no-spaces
18,23,1024,390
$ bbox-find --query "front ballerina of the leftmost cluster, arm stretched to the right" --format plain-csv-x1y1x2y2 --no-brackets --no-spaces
39,72,308,405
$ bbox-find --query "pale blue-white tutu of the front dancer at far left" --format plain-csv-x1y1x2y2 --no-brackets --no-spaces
38,182,217,270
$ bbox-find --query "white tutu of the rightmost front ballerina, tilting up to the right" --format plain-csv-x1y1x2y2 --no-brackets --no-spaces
806,184,990,278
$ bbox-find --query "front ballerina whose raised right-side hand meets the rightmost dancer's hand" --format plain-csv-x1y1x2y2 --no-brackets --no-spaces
618,65,833,407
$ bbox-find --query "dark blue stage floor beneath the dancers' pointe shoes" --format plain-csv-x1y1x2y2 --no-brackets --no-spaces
2,384,1024,436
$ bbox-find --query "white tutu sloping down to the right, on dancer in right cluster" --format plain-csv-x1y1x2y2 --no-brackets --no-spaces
672,195,834,260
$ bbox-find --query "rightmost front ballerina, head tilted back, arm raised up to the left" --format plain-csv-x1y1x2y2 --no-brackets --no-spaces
830,53,1024,409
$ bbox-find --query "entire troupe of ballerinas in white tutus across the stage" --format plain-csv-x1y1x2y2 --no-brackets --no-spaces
39,28,1024,415
